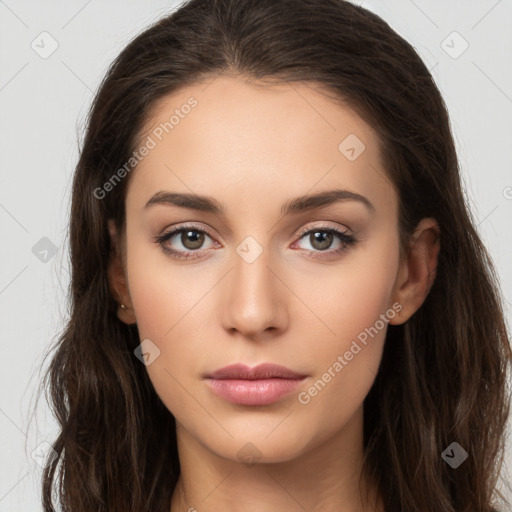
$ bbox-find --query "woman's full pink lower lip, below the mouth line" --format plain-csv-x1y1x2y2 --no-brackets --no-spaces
207,378,304,405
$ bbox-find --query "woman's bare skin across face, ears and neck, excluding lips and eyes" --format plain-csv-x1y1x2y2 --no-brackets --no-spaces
110,75,440,512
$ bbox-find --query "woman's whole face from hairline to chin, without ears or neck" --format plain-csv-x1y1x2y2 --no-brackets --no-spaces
117,76,408,462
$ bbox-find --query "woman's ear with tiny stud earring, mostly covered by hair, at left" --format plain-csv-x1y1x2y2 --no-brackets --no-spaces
108,219,136,324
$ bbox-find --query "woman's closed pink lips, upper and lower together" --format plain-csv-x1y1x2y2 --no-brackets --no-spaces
206,363,307,405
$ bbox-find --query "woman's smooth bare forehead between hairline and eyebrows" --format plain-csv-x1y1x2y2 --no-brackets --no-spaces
127,76,396,218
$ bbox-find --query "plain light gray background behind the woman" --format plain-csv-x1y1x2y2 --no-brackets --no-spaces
0,0,512,512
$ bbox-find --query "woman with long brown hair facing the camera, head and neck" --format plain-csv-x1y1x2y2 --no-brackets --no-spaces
43,0,511,512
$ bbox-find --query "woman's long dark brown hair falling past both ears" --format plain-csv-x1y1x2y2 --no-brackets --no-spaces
42,0,511,512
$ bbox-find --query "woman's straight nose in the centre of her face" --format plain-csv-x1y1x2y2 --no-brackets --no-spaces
222,247,288,340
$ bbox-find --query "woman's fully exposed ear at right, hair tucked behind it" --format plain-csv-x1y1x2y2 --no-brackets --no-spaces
389,218,441,325
